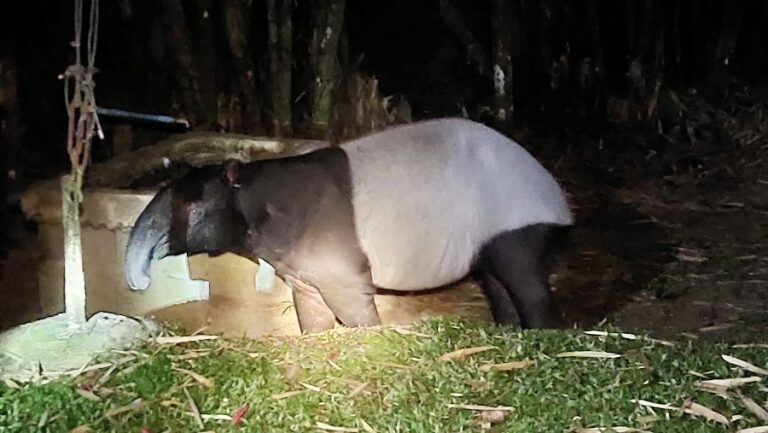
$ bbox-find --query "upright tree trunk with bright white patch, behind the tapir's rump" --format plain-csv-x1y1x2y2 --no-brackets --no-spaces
491,0,515,133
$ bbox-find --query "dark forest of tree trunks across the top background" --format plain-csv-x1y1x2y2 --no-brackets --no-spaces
0,0,768,195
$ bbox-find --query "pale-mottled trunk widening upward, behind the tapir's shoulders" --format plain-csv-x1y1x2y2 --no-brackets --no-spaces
309,0,346,137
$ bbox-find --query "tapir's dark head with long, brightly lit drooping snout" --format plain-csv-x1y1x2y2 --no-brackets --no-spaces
123,162,246,290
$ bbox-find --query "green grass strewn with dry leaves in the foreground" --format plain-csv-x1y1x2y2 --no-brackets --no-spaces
0,319,768,433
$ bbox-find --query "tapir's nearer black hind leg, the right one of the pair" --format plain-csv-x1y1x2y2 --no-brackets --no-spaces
480,224,561,328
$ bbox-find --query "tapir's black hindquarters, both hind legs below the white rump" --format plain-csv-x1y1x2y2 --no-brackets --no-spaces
473,224,562,328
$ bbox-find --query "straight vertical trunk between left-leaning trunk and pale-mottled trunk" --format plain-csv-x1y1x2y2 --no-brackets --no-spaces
267,0,293,137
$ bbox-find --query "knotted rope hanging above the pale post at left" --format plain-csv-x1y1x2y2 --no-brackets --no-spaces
59,0,104,203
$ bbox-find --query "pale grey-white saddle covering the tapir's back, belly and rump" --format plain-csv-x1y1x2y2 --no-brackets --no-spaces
341,119,572,290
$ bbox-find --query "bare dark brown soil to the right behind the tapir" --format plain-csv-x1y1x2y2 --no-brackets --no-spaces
553,154,768,343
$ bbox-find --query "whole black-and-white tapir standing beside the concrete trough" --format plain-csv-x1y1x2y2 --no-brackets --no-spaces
124,118,573,332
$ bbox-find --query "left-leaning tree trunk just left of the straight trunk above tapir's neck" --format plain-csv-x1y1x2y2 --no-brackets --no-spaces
223,0,264,134
